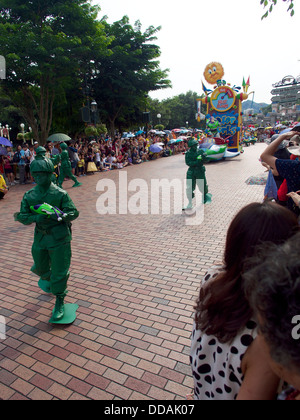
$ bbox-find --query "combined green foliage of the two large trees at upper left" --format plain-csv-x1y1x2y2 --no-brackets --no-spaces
0,0,171,144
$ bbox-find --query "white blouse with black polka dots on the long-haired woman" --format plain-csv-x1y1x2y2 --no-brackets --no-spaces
190,266,257,400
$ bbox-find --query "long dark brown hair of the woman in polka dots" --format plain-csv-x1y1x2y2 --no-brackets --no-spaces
195,202,299,343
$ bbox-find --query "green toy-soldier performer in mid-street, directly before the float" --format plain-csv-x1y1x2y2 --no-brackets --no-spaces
183,138,211,210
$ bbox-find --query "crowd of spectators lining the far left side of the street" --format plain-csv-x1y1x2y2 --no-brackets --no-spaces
0,133,188,186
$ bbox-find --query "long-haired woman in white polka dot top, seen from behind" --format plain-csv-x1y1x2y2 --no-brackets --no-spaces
190,202,299,400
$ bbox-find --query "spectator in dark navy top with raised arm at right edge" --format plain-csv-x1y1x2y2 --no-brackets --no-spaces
261,129,300,215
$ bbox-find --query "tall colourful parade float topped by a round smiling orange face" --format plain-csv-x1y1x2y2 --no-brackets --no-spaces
197,62,250,160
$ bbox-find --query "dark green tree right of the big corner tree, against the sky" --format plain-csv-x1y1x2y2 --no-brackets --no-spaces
93,16,171,135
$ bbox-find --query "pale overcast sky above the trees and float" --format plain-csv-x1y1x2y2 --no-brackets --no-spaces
92,0,300,103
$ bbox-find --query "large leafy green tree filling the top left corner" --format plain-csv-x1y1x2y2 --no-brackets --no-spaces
0,0,109,144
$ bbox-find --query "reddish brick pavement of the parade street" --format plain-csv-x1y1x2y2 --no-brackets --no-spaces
0,144,265,400
